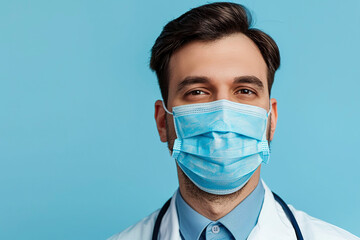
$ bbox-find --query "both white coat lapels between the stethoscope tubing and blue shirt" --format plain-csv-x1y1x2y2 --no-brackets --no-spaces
159,180,296,240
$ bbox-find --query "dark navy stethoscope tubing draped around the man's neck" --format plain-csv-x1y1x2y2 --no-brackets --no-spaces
152,193,304,240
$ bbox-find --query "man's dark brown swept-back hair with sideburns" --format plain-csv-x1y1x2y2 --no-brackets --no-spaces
150,2,280,103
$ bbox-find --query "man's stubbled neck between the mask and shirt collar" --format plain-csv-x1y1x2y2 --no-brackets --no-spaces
177,167,260,221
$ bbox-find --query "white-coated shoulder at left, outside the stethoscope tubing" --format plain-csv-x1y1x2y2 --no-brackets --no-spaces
107,210,159,240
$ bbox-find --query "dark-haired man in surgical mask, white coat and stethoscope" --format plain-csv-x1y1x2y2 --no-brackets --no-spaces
110,3,358,240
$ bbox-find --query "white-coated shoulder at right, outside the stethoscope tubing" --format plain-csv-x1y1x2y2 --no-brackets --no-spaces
289,205,360,240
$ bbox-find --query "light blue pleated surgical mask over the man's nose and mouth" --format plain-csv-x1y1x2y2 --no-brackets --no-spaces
164,100,270,195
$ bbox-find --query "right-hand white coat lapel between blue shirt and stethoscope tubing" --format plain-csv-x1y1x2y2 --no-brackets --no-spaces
248,180,296,240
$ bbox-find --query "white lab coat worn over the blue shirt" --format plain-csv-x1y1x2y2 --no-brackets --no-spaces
108,182,360,240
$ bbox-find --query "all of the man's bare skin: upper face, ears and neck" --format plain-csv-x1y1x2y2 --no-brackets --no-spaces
155,33,277,221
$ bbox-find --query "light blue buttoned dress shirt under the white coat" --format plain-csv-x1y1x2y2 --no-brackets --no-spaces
176,181,265,240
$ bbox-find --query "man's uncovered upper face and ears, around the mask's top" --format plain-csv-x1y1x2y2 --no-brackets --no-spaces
155,33,277,149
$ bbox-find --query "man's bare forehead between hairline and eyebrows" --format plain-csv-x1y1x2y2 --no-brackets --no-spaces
169,33,267,89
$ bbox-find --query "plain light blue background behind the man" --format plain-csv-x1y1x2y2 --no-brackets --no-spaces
0,0,360,240
